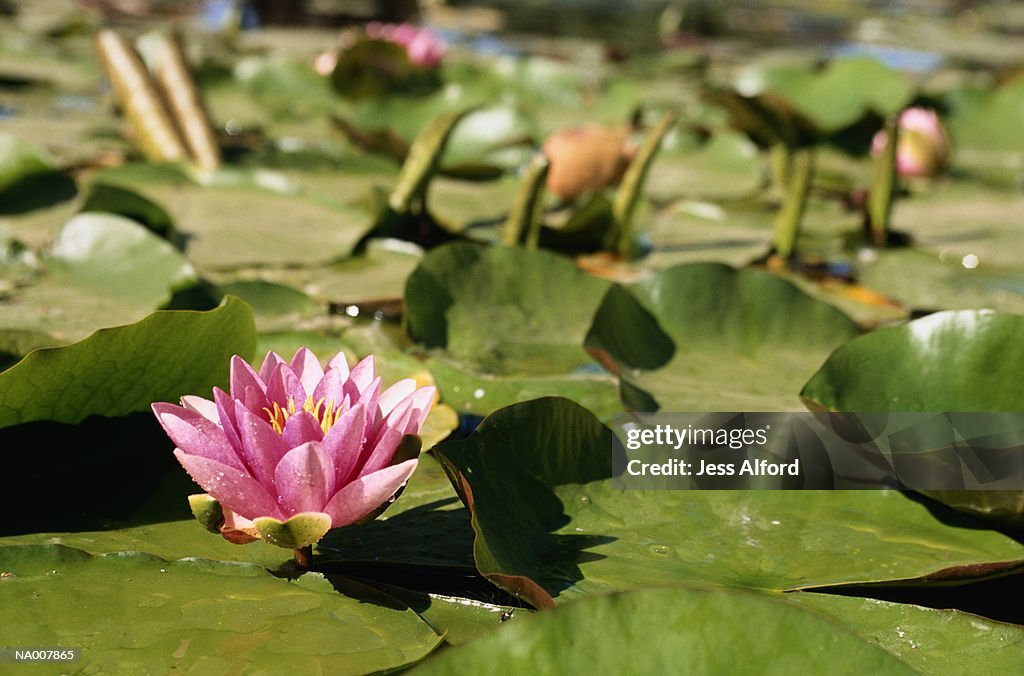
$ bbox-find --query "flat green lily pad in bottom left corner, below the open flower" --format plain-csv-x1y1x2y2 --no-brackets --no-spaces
0,545,440,674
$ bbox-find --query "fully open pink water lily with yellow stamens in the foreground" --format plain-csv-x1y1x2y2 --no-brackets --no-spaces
153,347,434,549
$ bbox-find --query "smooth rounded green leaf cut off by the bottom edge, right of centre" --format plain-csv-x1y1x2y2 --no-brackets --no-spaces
414,588,914,675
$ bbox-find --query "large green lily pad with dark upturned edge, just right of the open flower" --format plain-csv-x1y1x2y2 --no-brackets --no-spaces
434,398,1024,606
